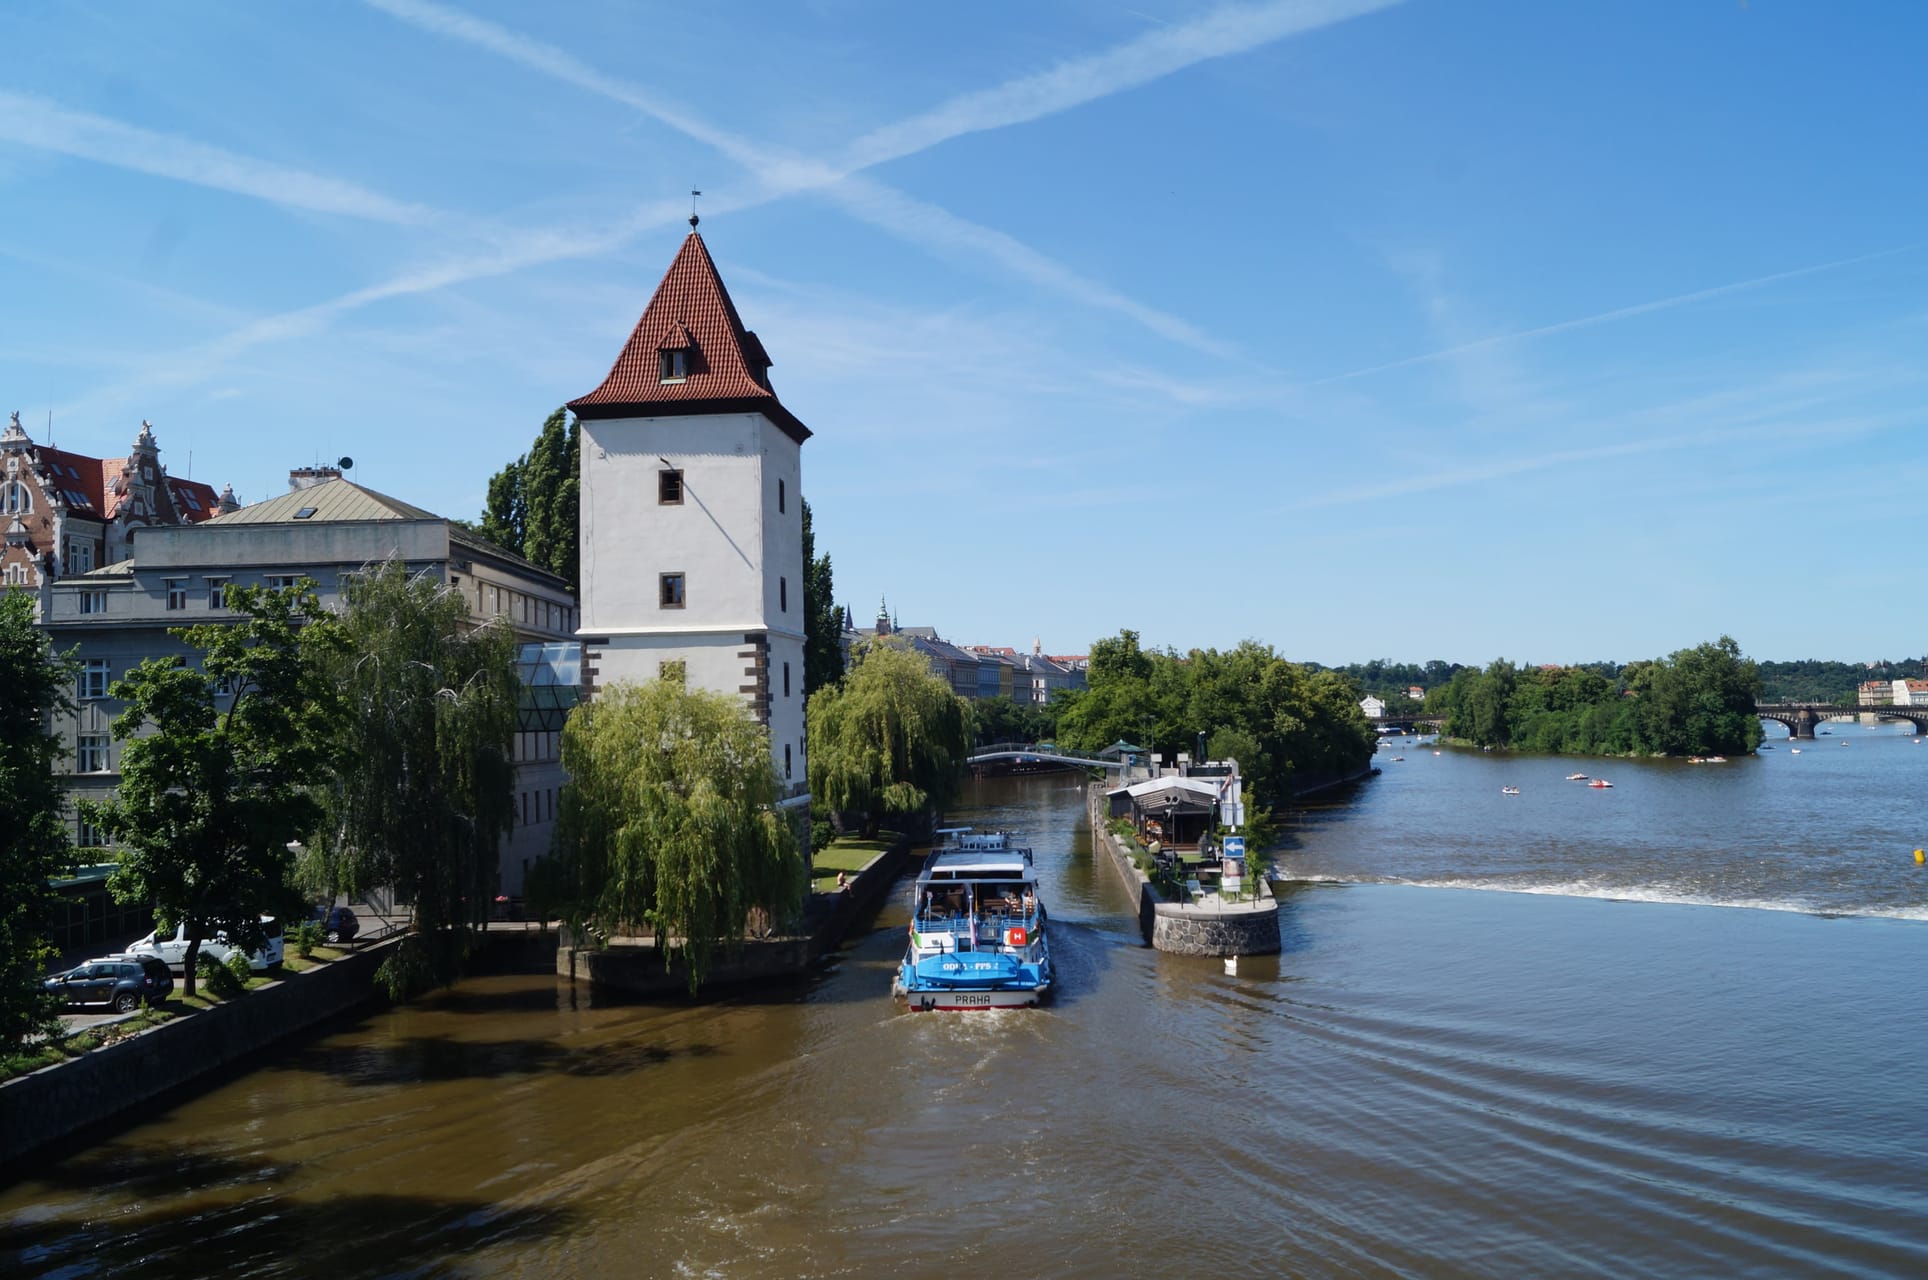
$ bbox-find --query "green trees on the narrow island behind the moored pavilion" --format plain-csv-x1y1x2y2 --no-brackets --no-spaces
1055,630,1373,806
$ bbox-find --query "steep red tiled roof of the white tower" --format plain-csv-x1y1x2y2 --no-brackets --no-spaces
569,231,810,443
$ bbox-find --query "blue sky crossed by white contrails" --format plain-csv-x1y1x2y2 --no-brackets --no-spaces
0,0,1928,663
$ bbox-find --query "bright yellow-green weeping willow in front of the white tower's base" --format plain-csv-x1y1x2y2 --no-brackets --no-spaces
555,673,810,993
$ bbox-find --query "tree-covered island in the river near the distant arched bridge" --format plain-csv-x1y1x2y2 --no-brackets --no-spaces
1427,636,1762,756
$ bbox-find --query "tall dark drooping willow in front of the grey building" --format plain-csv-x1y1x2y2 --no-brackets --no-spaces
312,561,521,997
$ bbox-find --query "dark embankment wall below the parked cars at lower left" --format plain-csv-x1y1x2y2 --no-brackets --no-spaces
0,943,393,1168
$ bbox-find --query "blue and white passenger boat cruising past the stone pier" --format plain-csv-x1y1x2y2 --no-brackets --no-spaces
891,827,1051,1012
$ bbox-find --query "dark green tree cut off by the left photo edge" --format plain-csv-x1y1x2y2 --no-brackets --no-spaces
0,592,73,1051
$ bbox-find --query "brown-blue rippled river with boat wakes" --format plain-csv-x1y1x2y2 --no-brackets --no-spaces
0,725,1928,1278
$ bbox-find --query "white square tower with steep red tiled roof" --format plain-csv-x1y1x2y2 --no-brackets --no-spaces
569,227,810,804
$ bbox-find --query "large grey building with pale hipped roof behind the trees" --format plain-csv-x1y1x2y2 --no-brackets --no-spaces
42,468,578,894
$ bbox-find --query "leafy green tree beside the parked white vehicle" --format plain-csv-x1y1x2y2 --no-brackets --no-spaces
81,586,341,995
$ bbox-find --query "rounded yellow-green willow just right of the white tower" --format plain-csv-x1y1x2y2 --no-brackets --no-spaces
808,638,970,837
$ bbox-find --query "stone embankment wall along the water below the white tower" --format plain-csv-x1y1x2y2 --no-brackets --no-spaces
555,837,912,997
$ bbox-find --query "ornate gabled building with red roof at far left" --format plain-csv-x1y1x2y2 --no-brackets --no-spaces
0,413,237,609
